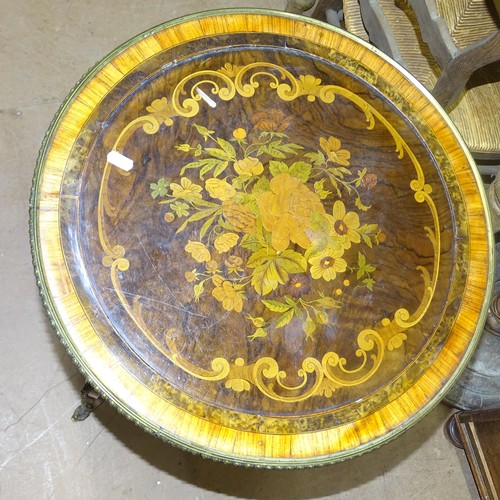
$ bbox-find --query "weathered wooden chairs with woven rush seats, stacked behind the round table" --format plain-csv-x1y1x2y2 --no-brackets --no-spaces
344,0,500,164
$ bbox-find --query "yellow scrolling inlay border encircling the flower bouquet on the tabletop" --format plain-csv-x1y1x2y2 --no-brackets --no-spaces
98,62,440,403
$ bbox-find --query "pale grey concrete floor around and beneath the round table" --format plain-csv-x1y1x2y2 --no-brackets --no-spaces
0,0,478,500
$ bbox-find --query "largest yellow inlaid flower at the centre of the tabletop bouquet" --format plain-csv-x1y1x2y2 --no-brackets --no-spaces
258,172,325,252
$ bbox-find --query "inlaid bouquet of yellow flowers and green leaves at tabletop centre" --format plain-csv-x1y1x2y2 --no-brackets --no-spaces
151,122,381,338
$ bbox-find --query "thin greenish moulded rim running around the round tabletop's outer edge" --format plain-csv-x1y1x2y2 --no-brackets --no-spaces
29,8,494,469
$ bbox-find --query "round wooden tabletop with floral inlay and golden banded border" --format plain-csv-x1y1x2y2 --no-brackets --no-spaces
31,10,493,467
